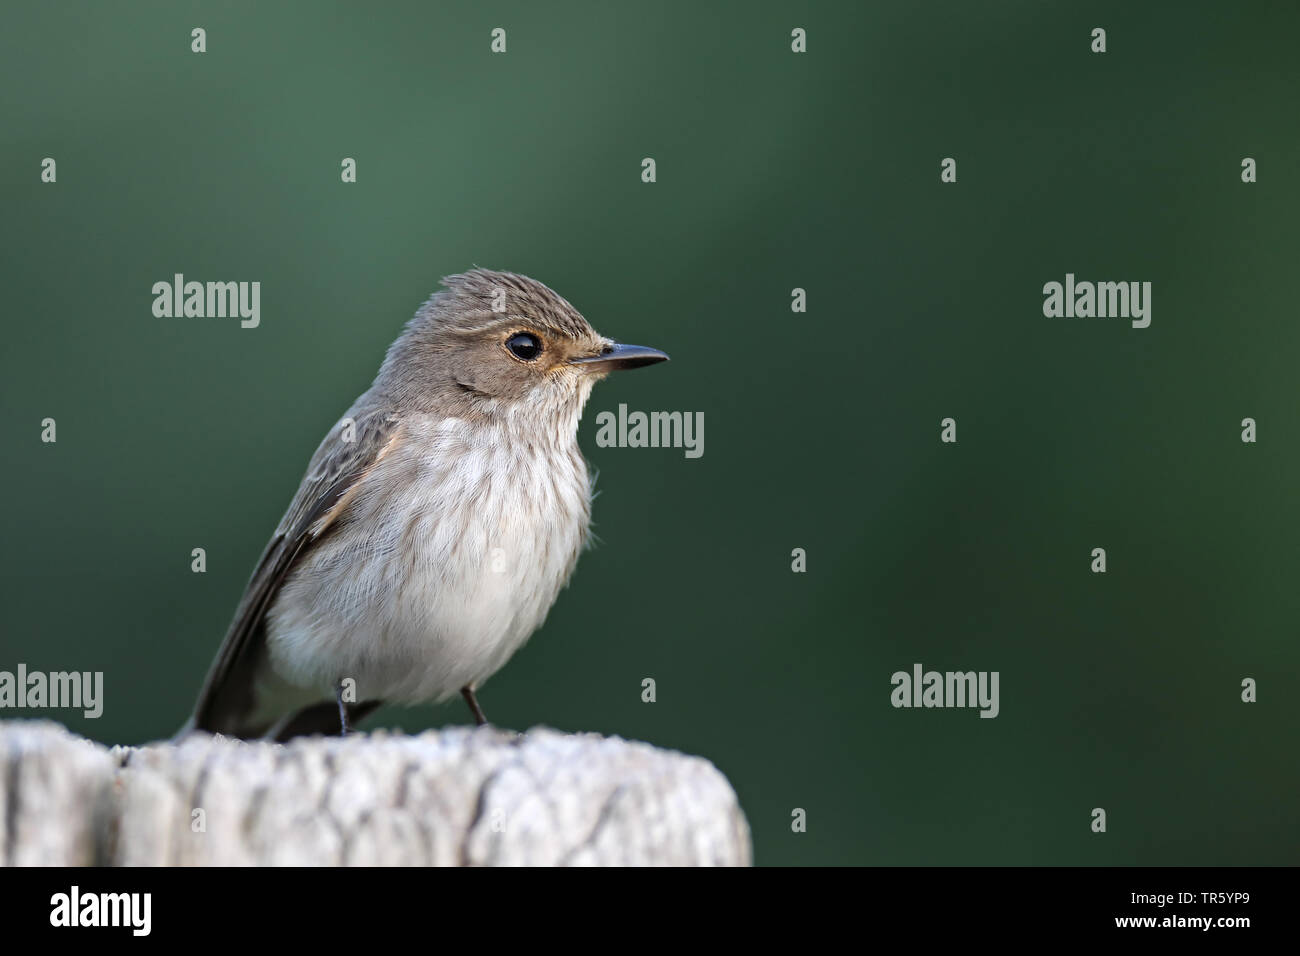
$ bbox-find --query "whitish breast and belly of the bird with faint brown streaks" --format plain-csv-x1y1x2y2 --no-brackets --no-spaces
269,419,590,702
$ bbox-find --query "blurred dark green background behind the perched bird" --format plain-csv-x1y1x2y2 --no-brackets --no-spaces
0,3,1300,864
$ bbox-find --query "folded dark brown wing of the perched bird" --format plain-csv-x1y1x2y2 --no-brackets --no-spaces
190,411,402,736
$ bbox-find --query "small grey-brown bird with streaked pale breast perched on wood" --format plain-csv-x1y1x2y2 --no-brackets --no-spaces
178,268,668,743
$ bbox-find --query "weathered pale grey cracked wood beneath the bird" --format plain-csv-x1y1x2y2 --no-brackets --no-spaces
0,721,750,866
